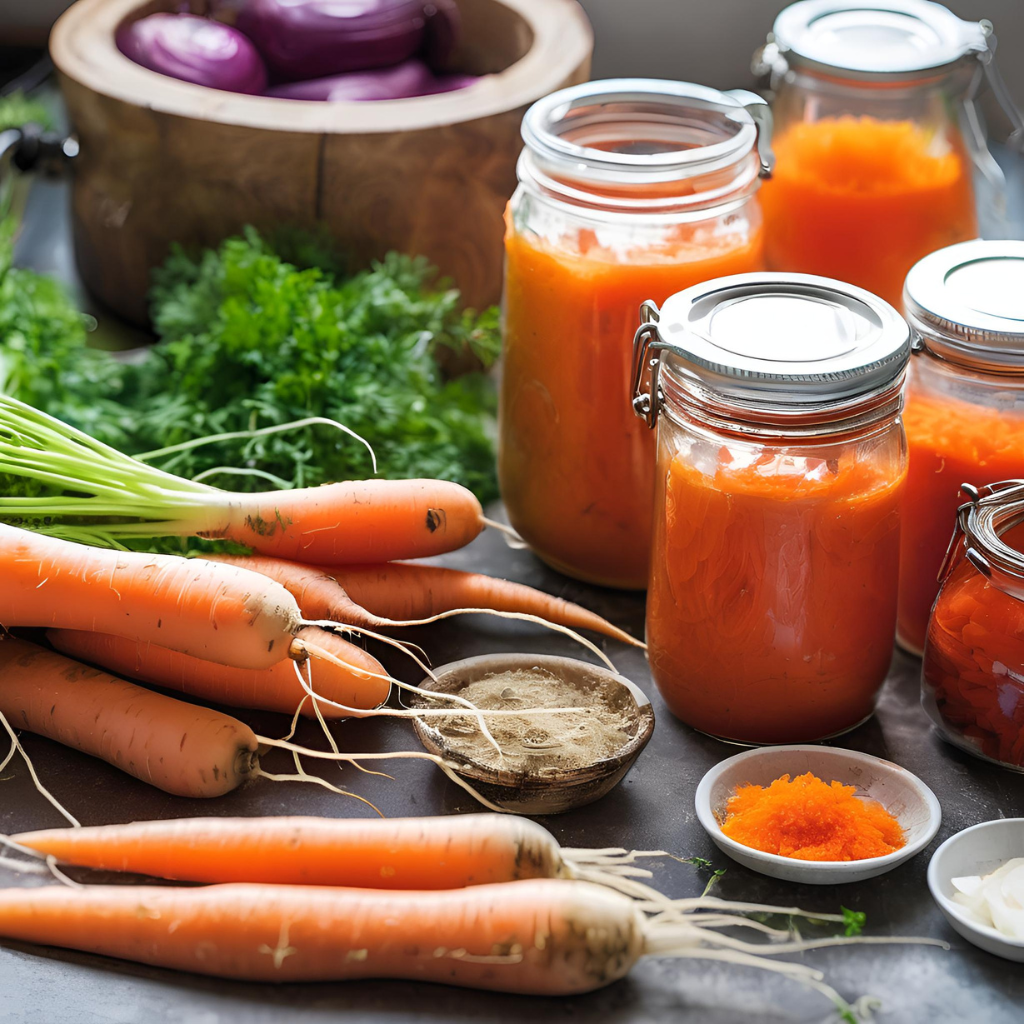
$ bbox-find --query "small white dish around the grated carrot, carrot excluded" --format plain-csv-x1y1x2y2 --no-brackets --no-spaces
695,743,942,886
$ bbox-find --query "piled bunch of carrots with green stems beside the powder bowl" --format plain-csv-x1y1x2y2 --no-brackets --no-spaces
0,398,637,797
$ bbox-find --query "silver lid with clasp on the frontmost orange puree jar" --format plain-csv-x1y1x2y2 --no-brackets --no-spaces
634,272,910,414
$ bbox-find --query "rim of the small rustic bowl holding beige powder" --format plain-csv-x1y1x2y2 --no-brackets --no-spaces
413,653,654,794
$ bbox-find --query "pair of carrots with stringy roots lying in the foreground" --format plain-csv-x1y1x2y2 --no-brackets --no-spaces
0,814,941,1021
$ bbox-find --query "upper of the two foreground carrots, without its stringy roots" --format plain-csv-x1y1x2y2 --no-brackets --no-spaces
13,814,572,889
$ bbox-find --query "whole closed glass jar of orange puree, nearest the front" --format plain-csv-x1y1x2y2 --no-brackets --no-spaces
634,273,910,743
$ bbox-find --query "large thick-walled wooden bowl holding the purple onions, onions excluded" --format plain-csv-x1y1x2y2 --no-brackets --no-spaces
50,0,593,323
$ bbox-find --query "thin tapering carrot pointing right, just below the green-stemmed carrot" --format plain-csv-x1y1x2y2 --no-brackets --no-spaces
210,554,643,646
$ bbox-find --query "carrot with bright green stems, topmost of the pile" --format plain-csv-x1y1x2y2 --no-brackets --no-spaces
0,395,485,564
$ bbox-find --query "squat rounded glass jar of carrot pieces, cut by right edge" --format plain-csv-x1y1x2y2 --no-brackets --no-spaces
922,480,1024,771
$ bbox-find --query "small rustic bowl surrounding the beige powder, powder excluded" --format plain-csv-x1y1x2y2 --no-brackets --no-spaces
414,654,654,814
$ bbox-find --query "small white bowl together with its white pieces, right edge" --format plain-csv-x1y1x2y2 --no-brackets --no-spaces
928,818,1024,964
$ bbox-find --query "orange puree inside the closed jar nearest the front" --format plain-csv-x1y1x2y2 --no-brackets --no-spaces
647,445,903,742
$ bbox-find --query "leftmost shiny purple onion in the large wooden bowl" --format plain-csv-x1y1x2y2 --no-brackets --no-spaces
116,14,267,93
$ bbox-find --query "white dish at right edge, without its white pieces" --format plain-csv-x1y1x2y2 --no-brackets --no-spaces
928,818,1024,964
